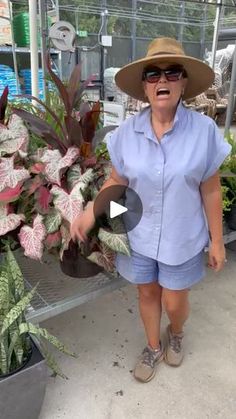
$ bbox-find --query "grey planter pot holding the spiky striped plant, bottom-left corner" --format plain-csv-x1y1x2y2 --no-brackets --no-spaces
0,341,47,419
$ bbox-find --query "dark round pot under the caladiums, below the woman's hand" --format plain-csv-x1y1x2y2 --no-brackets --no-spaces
60,242,103,278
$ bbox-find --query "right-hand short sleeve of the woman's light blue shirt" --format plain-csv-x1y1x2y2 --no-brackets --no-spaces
201,121,232,182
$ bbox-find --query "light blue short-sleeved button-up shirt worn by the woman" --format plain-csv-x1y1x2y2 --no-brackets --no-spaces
107,103,231,265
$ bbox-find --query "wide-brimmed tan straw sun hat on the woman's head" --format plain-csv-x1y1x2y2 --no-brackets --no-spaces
115,38,215,101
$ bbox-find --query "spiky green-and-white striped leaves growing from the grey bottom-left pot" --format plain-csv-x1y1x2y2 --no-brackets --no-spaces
0,246,75,378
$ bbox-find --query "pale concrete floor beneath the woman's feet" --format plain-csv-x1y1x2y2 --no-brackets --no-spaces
39,250,236,419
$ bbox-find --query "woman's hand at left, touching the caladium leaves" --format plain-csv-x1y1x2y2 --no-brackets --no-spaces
70,203,95,242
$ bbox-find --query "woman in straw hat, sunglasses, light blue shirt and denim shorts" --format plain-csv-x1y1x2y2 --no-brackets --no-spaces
71,38,230,382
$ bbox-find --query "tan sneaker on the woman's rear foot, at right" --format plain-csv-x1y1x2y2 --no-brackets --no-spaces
164,325,184,367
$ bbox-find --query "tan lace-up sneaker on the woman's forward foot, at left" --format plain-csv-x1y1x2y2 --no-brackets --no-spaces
134,343,164,383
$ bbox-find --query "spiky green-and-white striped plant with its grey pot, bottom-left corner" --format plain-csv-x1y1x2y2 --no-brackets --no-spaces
0,245,75,419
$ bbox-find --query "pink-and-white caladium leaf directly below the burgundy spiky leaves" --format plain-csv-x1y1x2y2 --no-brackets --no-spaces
41,147,79,185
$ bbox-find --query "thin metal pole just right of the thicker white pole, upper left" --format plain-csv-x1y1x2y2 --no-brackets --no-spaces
39,0,47,100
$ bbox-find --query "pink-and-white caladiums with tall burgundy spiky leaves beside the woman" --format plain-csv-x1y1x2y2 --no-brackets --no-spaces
0,59,129,271
